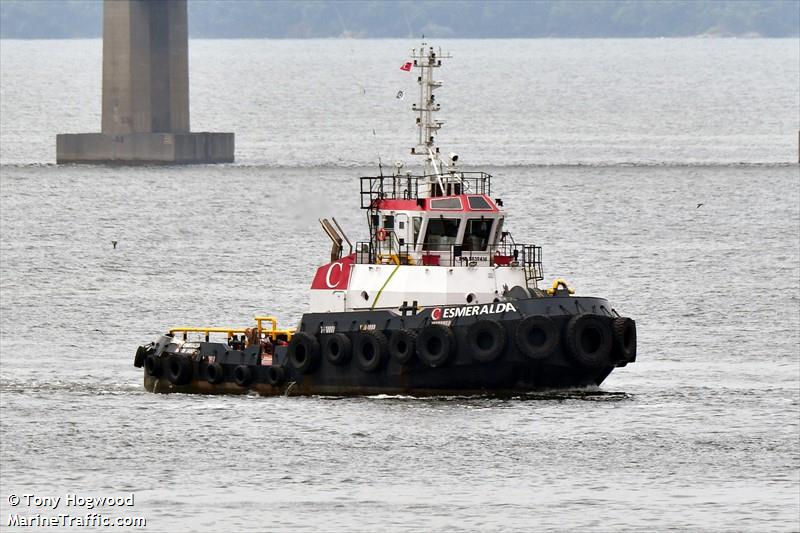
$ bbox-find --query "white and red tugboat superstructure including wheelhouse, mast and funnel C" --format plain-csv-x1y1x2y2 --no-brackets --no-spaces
309,43,542,312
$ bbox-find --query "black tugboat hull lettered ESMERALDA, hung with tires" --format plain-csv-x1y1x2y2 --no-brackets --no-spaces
140,296,636,396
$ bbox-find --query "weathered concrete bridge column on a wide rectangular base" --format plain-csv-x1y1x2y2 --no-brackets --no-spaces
56,0,234,164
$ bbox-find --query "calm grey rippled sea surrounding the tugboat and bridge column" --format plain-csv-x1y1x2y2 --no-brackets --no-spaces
0,39,800,532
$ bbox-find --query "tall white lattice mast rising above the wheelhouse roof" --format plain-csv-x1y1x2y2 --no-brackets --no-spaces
411,42,452,190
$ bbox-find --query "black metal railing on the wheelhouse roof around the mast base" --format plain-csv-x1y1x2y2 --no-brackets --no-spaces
361,171,492,209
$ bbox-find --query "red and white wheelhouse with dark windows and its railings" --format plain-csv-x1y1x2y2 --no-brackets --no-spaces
356,171,541,279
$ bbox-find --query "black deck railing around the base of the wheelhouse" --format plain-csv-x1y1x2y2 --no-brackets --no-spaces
356,240,544,282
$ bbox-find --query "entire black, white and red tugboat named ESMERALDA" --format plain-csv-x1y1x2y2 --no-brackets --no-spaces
134,43,636,396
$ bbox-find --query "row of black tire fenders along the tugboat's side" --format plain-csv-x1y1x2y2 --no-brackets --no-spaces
134,314,637,388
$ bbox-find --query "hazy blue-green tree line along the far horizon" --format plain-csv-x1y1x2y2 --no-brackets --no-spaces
0,0,800,39
